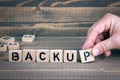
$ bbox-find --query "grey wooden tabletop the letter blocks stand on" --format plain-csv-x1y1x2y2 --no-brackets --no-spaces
0,37,120,80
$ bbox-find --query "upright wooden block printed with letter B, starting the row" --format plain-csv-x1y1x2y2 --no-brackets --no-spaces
9,50,22,62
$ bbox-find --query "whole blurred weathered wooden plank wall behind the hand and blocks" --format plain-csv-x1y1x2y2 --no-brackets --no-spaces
0,0,120,37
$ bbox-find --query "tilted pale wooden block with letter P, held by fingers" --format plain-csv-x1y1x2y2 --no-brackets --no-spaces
79,49,95,63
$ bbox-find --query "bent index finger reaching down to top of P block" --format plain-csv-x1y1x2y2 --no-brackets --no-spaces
82,14,111,49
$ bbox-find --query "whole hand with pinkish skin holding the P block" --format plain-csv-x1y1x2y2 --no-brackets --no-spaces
82,13,120,56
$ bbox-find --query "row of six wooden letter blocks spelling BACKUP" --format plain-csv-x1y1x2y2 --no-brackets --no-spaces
9,49,95,63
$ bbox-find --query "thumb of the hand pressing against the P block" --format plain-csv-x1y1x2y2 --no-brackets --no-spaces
92,38,115,56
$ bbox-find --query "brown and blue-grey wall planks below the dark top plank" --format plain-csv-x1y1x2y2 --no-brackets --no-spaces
0,7,120,36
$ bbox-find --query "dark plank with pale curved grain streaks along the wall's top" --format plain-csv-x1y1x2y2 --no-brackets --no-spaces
0,0,120,7
